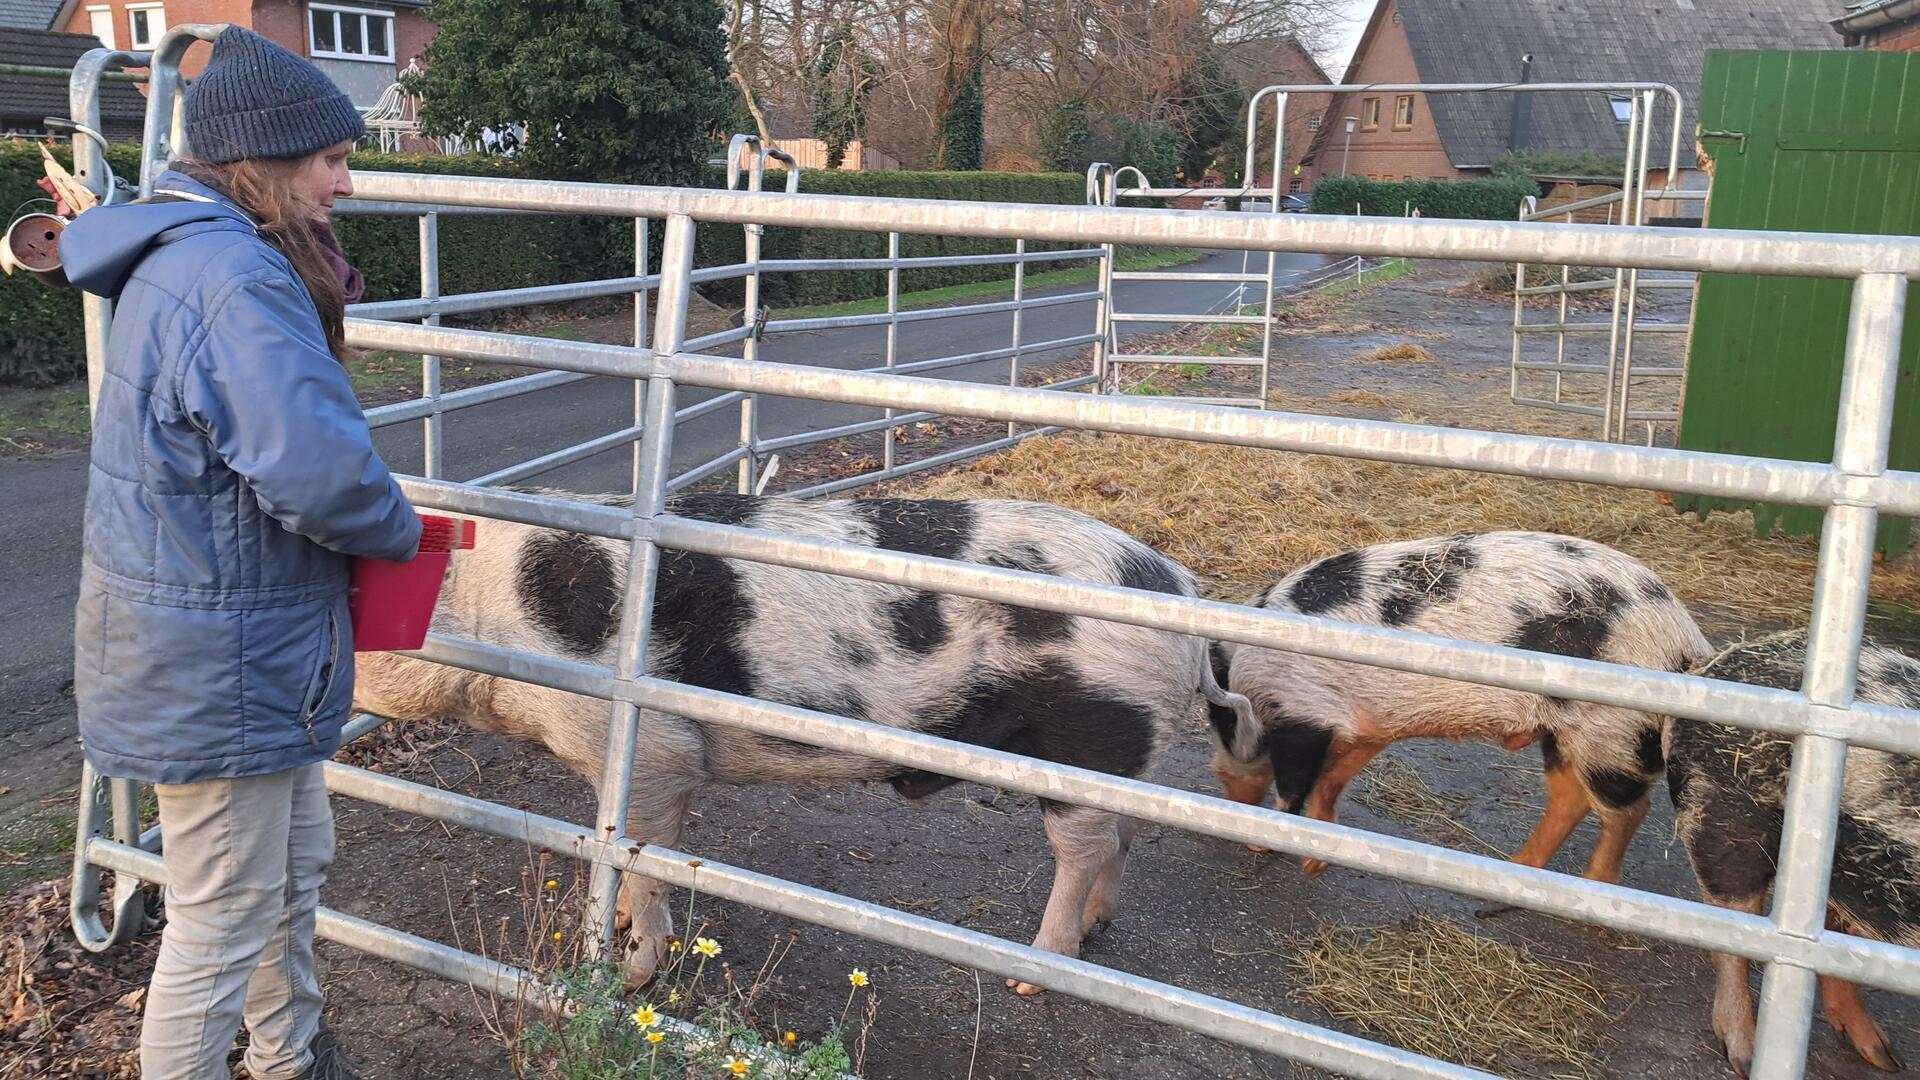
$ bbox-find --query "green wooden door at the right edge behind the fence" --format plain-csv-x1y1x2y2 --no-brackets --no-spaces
1676,50,1920,555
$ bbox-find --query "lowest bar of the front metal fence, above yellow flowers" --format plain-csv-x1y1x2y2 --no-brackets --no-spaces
295,763,1488,1080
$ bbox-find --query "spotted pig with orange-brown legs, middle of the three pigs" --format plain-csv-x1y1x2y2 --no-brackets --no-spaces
1212,532,1709,882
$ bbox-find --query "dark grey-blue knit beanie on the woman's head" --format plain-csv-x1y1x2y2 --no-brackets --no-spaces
186,27,367,163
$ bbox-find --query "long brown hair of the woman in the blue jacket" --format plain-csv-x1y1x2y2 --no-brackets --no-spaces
175,158,348,363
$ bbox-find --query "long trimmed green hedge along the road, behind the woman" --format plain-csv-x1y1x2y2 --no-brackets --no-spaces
0,140,1085,384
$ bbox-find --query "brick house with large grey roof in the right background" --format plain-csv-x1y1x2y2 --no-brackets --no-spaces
1308,0,1843,186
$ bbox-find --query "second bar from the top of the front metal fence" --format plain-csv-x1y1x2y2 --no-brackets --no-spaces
337,317,1920,517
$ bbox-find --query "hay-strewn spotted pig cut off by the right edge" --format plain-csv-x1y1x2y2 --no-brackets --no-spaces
1665,630,1920,1076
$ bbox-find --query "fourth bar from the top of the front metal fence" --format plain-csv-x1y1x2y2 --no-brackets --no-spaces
389,630,1920,1003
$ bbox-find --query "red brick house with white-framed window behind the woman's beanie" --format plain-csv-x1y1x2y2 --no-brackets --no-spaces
49,0,434,110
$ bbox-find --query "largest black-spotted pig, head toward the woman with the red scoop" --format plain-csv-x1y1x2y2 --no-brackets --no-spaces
355,492,1252,994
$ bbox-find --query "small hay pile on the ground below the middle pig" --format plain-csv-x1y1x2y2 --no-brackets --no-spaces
1290,915,1613,1074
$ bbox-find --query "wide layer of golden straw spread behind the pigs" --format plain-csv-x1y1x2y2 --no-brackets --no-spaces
891,379,1920,625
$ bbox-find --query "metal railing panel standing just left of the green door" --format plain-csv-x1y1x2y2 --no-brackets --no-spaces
1507,190,1707,446
